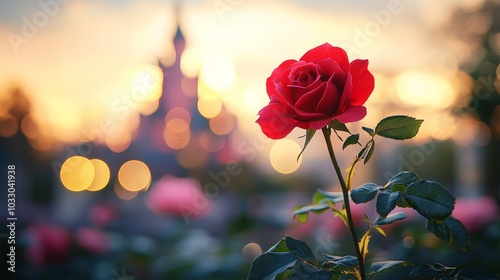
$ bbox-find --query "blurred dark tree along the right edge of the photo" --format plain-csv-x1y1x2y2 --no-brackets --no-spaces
451,0,500,204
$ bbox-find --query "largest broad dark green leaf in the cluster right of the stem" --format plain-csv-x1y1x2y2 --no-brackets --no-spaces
404,180,455,220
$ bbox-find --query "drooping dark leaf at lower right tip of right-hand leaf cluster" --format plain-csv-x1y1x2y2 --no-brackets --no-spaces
427,216,469,251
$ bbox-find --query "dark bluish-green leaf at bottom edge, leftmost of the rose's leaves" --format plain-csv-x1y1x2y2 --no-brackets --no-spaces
247,252,299,280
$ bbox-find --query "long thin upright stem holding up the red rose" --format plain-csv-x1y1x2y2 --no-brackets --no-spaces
322,126,366,280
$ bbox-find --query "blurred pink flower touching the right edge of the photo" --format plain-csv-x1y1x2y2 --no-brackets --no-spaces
453,196,499,232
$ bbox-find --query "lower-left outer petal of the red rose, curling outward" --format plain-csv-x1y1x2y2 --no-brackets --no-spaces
256,103,297,139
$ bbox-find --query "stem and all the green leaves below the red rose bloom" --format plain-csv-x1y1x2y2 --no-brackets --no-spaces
248,116,484,280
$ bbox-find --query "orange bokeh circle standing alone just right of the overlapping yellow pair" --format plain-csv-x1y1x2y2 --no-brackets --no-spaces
118,160,151,192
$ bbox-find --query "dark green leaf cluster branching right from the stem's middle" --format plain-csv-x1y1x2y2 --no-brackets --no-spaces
351,171,469,250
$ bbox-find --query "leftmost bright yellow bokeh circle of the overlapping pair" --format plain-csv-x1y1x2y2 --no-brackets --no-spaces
60,156,95,192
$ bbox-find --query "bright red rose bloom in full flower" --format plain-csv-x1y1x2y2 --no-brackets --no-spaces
257,43,374,139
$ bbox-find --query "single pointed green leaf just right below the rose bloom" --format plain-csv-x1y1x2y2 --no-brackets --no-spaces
375,116,423,140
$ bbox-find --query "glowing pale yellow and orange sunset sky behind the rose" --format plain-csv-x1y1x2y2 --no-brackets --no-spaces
0,0,487,173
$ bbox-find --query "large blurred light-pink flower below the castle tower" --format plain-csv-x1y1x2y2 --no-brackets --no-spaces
146,175,211,218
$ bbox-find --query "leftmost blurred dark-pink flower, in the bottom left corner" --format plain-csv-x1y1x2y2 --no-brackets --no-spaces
26,225,71,265
